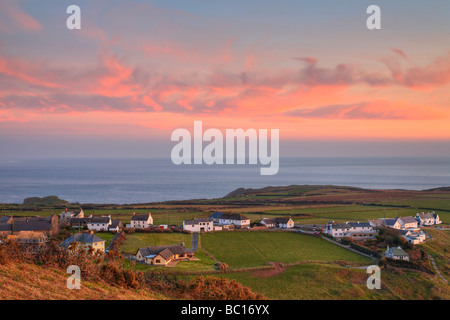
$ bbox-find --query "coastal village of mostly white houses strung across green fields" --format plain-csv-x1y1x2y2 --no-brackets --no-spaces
0,208,442,267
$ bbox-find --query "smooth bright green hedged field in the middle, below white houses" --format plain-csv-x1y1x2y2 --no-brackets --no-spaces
201,232,371,268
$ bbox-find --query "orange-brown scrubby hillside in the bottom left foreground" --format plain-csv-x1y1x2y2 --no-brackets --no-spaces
0,235,265,300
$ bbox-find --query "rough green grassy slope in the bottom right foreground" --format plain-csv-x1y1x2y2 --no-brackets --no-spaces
215,264,450,300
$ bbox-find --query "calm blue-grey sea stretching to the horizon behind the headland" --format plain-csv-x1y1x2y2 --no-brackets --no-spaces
0,158,450,204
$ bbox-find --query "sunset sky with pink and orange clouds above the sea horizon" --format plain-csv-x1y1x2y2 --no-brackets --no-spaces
0,0,450,158
